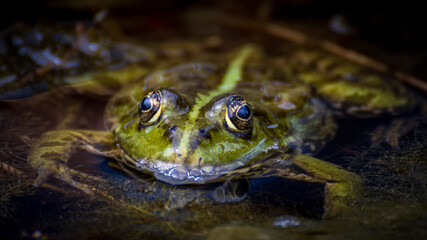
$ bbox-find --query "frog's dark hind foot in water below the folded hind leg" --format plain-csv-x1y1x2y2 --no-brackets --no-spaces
371,116,422,148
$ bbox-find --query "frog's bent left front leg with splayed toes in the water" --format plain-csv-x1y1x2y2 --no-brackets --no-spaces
27,130,120,194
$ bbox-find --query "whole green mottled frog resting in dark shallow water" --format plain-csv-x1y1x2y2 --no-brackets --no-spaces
27,44,417,216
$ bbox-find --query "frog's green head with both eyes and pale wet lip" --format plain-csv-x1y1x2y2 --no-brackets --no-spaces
116,88,283,184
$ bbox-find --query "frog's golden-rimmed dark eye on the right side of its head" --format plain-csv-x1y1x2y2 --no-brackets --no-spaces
225,96,253,138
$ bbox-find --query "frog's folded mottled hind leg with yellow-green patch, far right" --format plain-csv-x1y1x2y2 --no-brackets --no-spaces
289,50,417,117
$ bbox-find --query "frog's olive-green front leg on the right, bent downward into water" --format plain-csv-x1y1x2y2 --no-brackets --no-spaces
292,155,362,217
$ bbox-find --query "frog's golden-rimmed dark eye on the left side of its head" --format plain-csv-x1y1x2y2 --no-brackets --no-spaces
139,90,162,126
